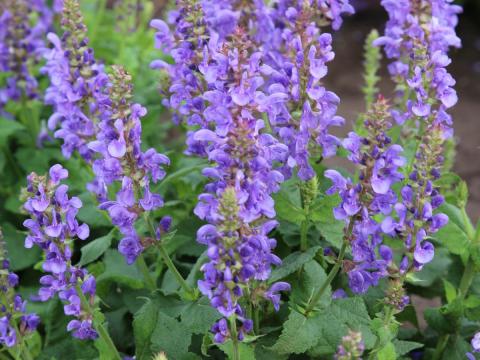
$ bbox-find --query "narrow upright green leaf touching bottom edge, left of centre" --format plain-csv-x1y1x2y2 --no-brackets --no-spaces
133,300,158,360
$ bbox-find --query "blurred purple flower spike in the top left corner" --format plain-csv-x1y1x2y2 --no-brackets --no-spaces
0,0,51,115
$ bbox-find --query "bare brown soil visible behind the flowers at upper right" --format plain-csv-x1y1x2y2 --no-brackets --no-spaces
326,6,480,221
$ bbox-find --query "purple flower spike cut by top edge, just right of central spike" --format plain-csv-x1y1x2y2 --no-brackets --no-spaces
256,0,353,180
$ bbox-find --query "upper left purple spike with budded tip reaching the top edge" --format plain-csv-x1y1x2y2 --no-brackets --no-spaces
43,0,108,161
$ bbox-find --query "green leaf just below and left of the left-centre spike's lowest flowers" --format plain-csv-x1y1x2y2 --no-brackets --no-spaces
97,249,144,289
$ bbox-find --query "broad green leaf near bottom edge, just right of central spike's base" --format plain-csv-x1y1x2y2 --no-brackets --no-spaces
271,310,322,355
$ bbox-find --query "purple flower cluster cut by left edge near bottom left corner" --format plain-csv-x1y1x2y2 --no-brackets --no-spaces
0,232,40,347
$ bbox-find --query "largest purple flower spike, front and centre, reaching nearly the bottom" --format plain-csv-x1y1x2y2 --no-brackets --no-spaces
181,24,290,342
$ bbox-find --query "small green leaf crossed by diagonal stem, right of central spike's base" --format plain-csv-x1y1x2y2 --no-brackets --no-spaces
291,260,332,307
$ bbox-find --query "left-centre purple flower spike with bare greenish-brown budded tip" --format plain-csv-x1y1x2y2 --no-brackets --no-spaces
88,66,169,264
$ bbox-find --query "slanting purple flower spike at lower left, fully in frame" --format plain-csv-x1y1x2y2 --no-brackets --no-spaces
24,164,98,339
